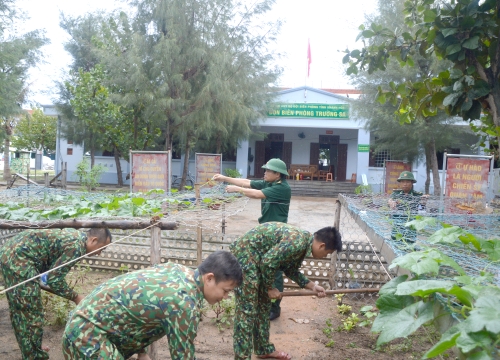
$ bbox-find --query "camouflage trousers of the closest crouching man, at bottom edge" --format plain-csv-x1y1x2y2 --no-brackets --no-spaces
62,314,146,360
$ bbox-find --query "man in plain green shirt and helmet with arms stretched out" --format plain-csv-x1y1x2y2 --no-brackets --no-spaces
213,159,292,320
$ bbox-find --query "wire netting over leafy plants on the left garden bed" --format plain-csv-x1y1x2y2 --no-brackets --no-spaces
0,184,248,231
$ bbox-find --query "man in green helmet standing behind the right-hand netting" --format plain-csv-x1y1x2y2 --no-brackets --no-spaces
389,171,423,243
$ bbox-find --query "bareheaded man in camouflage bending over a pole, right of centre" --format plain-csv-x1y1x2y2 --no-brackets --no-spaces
230,222,342,360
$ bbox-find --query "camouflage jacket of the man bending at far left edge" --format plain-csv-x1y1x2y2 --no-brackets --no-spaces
0,229,87,300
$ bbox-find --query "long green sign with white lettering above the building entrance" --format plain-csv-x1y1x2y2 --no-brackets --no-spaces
267,104,349,120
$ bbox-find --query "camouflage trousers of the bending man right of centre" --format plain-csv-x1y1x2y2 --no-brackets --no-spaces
233,255,274,359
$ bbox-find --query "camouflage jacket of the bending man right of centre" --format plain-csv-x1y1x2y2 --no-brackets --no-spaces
230,222,314,289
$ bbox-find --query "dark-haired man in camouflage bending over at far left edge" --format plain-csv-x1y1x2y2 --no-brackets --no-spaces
0,229,111,359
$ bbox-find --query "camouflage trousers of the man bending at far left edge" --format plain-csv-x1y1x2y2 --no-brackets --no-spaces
0,264,49,360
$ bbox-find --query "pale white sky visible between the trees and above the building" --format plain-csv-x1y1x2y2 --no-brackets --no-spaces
18,0,377,105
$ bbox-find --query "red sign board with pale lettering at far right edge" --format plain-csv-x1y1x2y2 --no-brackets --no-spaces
446,157,490,200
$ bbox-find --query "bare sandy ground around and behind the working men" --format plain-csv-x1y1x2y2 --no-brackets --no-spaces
0,197,446,360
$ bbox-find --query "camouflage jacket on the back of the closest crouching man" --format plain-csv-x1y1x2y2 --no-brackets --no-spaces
65,263,204,360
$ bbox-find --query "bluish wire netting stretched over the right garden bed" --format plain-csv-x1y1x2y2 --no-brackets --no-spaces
341,194,500,285
